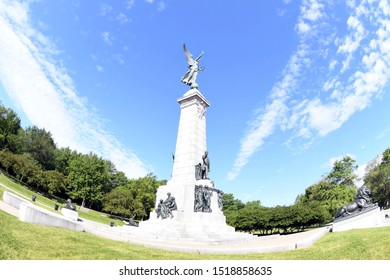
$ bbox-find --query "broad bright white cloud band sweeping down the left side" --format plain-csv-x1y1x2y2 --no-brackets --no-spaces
0,1,151,177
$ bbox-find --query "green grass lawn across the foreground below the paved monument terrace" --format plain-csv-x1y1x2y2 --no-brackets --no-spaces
0,211,390,260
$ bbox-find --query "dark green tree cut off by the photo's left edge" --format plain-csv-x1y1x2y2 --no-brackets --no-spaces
0,103,21,150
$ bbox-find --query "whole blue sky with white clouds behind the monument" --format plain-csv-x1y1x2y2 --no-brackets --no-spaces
0,0,390,206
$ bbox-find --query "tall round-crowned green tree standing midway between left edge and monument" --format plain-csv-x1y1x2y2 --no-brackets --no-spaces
68,153,109,207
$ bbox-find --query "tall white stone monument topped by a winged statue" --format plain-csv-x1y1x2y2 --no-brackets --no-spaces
139,45,253,241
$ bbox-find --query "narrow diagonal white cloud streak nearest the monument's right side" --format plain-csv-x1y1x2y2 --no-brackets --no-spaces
227,0,323,180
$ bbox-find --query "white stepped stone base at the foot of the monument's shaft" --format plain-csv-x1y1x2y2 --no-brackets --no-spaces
133,180,255,244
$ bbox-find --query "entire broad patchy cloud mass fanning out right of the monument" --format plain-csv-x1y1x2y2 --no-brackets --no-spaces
227,0,390,180
